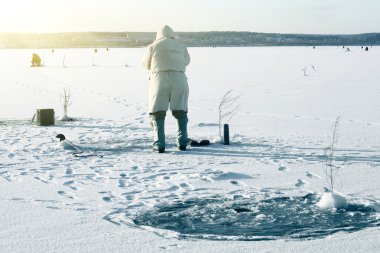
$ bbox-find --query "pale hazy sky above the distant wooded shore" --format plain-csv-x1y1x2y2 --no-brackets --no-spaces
0,0,380,34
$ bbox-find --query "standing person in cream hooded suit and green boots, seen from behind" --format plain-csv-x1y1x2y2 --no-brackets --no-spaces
143,25,190,153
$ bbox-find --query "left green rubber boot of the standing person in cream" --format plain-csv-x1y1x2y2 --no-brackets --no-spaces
150,111,166,153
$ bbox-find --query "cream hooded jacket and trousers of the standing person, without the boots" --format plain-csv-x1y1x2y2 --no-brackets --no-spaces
143,26,190,113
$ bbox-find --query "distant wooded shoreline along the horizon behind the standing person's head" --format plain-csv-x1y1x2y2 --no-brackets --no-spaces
0,32,380,48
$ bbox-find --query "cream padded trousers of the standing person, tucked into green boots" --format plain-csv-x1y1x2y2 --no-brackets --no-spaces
148,71,189,113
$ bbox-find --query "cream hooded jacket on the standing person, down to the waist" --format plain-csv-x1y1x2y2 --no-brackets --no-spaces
143,25,190,74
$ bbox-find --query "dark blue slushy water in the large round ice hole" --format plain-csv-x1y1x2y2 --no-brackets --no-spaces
134,194,380,240
